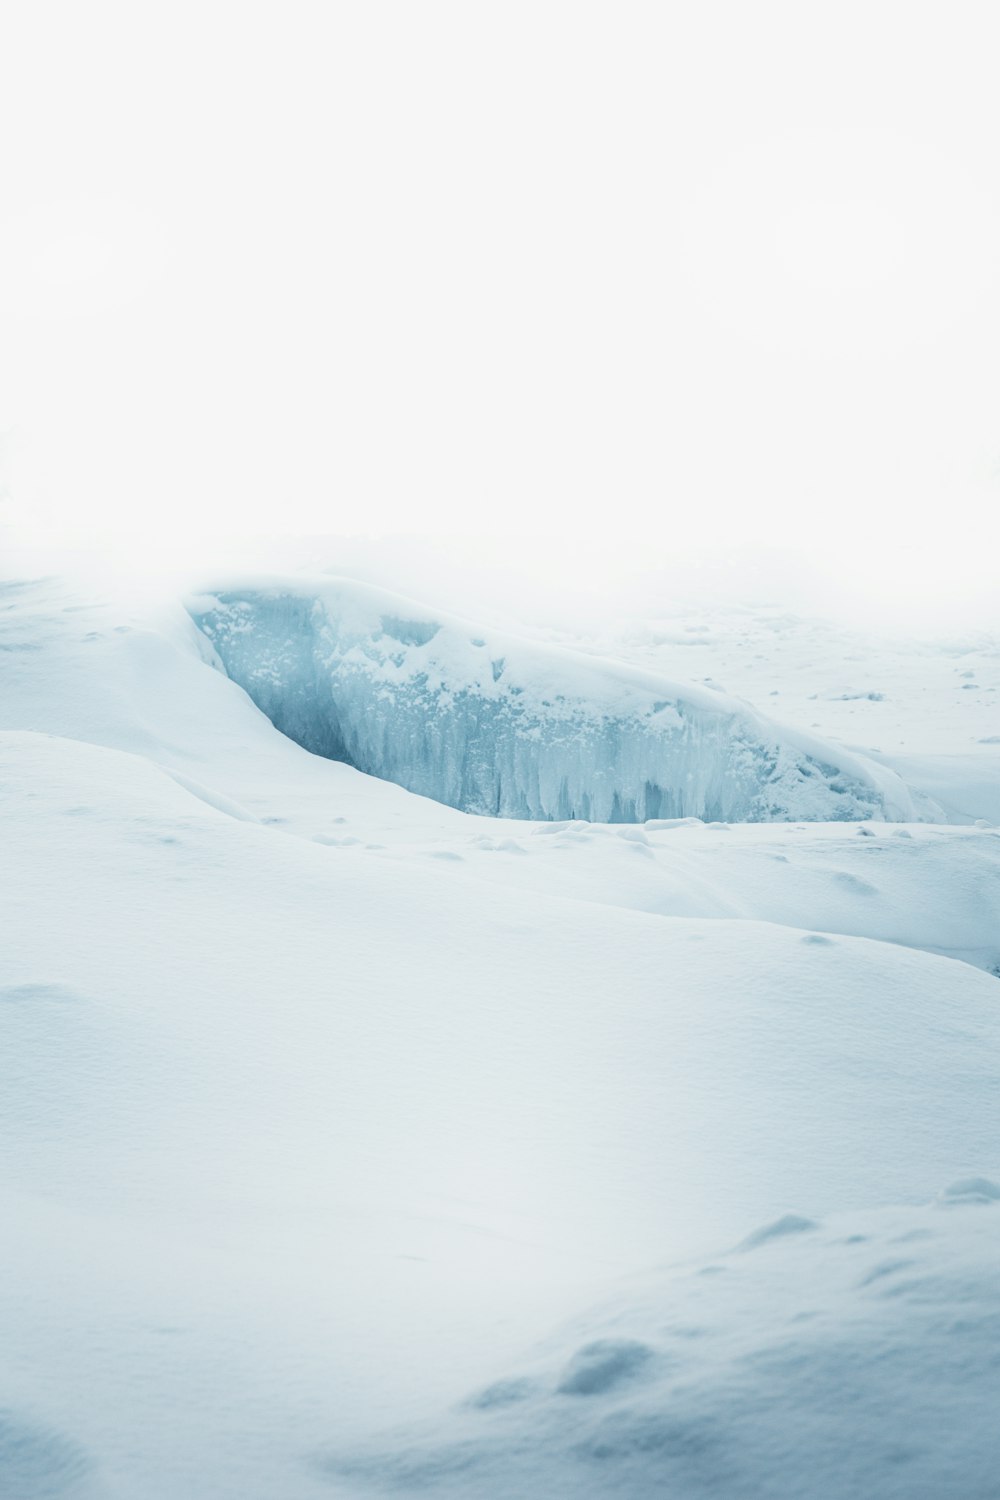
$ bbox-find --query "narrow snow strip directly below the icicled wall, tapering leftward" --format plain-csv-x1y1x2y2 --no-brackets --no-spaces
377,818,1000,975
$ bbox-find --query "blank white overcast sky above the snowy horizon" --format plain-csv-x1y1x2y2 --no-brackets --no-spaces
0,0,1000,615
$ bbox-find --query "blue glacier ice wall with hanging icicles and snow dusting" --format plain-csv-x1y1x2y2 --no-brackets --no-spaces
189,579,913,822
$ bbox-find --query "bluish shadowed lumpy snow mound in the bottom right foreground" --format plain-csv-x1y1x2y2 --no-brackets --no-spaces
326,1185,1000,1500
